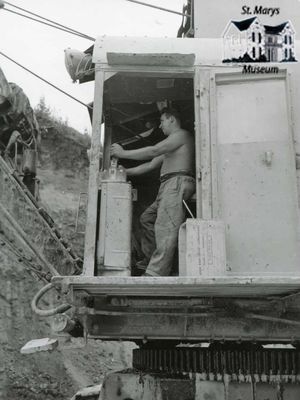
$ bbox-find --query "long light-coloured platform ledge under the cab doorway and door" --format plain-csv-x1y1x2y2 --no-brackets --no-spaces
52,276,300,297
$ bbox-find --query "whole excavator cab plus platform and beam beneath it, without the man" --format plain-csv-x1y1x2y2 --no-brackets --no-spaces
52,37,300,350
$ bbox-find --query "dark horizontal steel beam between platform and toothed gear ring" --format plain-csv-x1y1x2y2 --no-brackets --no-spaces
84,307,300,340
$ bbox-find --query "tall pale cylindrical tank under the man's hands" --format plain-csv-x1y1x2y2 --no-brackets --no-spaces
97,162,132,276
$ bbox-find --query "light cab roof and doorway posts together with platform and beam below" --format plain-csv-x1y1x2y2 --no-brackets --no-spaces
52,38,300,343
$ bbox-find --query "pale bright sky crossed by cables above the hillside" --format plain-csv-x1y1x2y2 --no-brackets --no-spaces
0,0,185,133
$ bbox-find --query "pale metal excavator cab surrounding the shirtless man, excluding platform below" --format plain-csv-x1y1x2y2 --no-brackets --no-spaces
79,38,299,283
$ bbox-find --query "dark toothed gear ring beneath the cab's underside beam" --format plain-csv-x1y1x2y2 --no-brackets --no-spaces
133,347,300,383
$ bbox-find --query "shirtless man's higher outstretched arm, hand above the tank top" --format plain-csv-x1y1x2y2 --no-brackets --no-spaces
111,131,185,160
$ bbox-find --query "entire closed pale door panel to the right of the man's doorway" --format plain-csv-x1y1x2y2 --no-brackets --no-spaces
216,76,300,276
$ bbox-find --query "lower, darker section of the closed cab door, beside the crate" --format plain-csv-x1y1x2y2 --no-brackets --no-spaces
219,142,299,275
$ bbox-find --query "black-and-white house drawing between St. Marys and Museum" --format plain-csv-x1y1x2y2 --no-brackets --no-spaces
223,17,296,62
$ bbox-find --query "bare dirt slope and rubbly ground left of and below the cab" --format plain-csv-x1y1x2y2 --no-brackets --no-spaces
0,124,135,400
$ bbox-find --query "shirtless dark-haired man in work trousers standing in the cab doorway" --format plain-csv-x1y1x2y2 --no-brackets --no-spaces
111,108,195,276
